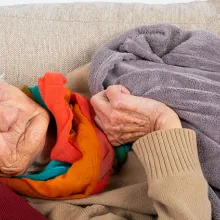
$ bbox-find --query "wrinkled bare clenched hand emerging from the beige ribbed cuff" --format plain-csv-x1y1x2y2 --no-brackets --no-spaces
90,85,181,146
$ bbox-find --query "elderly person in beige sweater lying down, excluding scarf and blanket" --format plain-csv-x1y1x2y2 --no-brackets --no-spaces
0,64,211,220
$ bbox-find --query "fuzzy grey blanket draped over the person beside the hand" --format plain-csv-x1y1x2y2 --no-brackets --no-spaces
89,24,220,220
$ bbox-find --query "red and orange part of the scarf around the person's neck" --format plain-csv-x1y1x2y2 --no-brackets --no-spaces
0,73,114,199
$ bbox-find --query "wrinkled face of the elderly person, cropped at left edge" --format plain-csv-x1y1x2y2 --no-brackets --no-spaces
0,83,50,176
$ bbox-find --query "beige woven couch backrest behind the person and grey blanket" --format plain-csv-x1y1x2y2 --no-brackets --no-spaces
0,0,220,86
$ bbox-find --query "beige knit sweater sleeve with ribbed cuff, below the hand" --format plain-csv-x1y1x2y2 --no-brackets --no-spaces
133,129,211,220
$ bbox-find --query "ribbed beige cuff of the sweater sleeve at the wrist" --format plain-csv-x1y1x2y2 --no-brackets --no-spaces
133,129,201,180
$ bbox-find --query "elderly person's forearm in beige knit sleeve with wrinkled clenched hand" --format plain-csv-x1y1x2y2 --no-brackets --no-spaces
91,85,211,220
